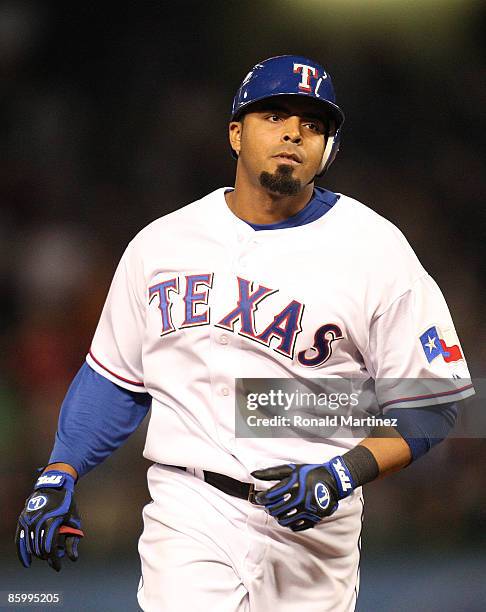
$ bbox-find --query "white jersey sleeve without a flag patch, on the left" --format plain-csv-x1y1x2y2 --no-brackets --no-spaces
86,242,146,392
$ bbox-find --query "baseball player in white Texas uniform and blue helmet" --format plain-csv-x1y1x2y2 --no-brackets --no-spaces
16,55,474,612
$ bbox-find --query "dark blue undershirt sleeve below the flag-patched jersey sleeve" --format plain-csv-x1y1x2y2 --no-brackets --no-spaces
386,402,457,461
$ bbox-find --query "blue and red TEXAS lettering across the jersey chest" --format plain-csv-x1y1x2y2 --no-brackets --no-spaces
149,273,343,367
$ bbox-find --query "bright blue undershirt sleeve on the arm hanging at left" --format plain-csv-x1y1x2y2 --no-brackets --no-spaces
49,363,152,476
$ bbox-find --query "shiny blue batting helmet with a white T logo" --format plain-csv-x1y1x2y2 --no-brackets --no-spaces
230,55,344,176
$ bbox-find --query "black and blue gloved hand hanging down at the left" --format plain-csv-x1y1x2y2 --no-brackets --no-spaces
15,470,84,572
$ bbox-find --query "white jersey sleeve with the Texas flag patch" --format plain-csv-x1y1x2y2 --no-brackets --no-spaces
363,273,474,412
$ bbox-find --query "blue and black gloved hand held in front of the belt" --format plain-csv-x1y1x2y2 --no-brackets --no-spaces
252,457,355,531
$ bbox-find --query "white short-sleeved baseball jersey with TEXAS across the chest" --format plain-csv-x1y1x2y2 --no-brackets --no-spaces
87,188,473,482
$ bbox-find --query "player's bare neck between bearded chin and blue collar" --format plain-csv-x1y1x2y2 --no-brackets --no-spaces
225,177,314,224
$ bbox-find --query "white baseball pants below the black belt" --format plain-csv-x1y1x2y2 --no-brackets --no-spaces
138,464,363,612
